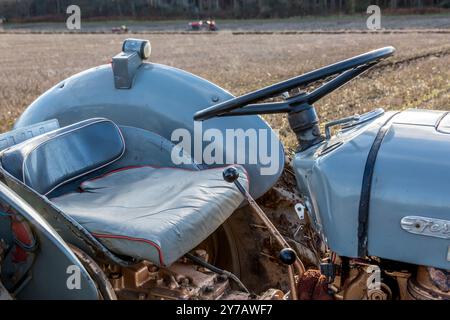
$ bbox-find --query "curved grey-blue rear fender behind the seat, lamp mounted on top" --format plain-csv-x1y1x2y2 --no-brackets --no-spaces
15,63,284,198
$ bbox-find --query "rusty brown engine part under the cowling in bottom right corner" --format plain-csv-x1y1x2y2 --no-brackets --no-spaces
407,266,450,300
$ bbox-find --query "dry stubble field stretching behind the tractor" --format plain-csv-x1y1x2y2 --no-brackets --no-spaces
0,33,450,151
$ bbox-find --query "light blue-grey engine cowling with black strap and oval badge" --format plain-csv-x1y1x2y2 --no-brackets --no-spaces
295,110,450,269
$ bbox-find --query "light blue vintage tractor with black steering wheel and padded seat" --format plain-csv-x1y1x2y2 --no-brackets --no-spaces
0,39,450,300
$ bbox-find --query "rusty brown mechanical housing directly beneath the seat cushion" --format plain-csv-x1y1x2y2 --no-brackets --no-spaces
104,259,284,300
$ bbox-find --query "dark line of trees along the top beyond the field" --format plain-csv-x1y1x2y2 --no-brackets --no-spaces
0,0,450,20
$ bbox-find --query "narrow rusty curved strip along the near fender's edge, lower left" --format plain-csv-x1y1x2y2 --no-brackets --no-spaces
69,244,117,300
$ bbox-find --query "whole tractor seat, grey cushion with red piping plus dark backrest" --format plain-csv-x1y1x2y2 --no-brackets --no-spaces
1,119,248,266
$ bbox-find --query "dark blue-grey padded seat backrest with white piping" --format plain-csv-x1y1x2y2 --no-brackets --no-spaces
1,118,125,195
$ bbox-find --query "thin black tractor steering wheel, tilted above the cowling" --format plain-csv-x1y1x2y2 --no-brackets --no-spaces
194,47,395,121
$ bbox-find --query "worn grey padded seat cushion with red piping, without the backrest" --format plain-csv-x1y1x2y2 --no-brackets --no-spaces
51,166,248,266
